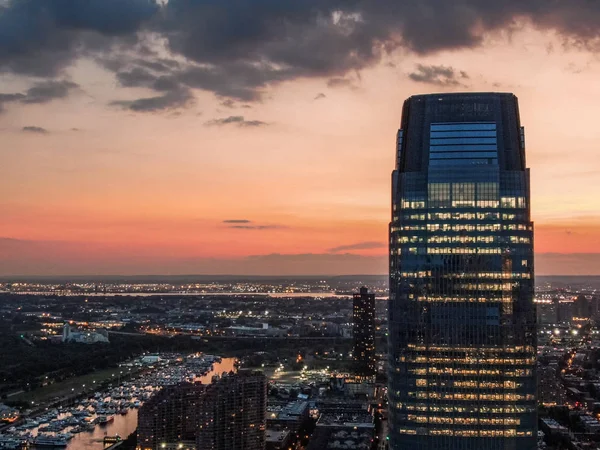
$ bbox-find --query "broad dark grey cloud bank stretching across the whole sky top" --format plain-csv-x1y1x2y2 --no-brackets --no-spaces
8,0,600,106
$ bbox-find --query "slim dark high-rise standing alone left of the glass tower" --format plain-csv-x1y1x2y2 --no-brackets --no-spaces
352,287,376,377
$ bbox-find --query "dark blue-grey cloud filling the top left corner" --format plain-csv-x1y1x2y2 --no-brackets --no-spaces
0,0,159,76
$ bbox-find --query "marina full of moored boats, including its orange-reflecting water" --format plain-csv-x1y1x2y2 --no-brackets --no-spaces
0,354,236,450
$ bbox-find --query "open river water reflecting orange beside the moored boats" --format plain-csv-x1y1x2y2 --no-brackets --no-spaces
67,358,235,450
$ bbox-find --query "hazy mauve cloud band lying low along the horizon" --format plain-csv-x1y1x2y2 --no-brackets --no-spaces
0,237,600,276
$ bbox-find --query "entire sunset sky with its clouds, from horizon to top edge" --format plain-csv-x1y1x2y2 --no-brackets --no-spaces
0,0,600,275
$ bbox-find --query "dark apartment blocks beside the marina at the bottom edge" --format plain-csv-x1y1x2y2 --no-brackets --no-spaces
137,370,267,450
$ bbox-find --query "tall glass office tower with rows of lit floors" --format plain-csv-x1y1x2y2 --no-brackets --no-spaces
388,93,537,450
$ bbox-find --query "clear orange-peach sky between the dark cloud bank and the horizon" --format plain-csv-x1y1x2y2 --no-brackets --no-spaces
0,29,600,275
